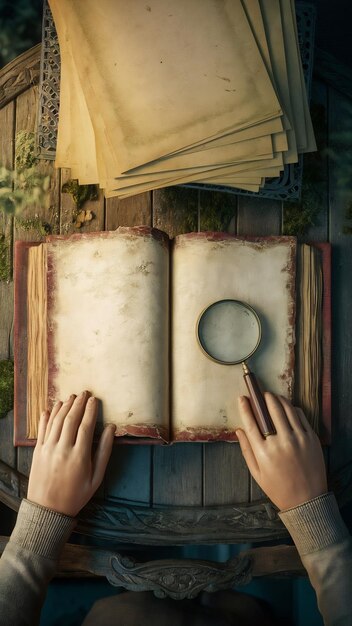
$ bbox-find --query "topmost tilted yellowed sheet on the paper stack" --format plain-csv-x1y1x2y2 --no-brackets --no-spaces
51,0,281,172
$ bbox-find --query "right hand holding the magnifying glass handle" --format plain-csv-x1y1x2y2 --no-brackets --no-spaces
236,392,328,510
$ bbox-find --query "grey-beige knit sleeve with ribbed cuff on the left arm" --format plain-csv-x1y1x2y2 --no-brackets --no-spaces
0,500,76,626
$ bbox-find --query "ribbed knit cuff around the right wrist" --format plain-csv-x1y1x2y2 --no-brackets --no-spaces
279,492,350,556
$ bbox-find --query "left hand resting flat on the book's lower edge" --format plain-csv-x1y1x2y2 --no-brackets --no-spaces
27,391,115,517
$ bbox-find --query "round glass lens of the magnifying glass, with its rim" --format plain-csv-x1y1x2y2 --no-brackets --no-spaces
198,300,260,363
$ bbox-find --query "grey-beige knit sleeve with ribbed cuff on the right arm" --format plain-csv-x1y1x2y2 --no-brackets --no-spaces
279,492,352,626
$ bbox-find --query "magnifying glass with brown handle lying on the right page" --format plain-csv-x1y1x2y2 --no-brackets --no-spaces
197,299,276,437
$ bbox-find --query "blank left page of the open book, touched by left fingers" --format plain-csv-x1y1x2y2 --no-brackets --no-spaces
47,228,169,439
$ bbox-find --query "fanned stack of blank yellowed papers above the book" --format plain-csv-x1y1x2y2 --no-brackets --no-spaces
49,0,316,197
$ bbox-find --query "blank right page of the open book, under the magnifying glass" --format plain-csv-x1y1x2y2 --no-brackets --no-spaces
171,232,296,441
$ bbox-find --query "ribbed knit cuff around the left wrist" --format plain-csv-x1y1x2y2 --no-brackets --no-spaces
10,499,76,560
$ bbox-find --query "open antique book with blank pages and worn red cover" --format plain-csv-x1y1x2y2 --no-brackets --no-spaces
15,226,328,445
